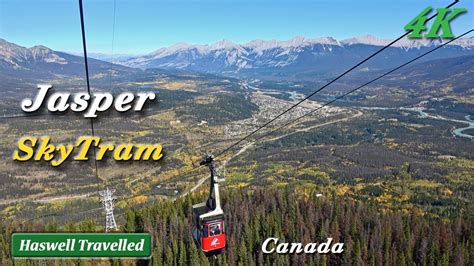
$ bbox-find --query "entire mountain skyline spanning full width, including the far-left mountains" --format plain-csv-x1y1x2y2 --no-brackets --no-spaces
0,35,474,80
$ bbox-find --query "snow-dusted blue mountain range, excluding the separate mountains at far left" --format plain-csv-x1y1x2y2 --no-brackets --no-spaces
117,35,474,78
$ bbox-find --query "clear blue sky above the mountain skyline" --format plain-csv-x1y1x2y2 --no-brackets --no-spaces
0,0,474,54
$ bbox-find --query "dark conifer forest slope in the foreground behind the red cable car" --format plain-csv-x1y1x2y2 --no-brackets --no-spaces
0,187,474,265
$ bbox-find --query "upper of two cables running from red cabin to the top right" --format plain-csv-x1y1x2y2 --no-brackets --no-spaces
216,0,458,158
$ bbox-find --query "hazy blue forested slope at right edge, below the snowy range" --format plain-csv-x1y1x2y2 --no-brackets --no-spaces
320,55,474,108
